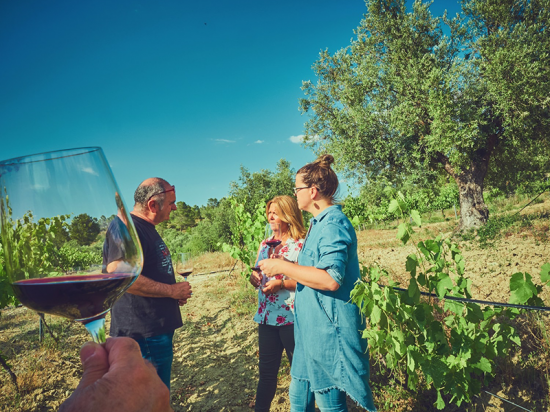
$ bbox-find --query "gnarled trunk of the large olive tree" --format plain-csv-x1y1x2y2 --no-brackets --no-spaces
455,164,489,230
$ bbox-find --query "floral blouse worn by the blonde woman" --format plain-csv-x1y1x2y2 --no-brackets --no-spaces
254,238,304,326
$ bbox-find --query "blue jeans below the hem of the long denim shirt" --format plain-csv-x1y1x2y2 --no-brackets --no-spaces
288,379,348,412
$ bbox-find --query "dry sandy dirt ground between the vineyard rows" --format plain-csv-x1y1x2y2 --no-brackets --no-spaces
0,202,550,412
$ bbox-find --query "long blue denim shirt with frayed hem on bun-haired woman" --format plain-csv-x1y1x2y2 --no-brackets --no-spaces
290,205,376,411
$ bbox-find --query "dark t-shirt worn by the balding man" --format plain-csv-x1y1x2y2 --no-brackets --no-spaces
104,215,183,339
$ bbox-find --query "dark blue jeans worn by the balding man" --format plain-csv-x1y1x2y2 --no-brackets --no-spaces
136,332,174,390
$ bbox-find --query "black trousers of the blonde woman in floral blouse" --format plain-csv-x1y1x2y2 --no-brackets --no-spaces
254,324,294,412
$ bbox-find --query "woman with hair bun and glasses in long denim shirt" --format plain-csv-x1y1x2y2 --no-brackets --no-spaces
259,155,376,412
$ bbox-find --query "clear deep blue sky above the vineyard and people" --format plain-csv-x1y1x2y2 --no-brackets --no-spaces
0,0,464,206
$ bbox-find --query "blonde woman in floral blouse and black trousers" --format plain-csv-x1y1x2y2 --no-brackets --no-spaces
250,196,306,412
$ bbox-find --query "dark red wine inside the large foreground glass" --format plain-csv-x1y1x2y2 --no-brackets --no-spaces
12,273,137,320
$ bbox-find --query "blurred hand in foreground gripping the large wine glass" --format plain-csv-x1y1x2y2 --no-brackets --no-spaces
59,338,172,412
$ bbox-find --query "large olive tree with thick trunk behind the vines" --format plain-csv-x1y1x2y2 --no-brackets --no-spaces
300,0,550,228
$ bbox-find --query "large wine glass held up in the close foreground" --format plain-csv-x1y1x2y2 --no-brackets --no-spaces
0,147,143,342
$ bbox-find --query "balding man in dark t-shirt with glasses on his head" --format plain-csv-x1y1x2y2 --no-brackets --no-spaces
103,178,192,389
